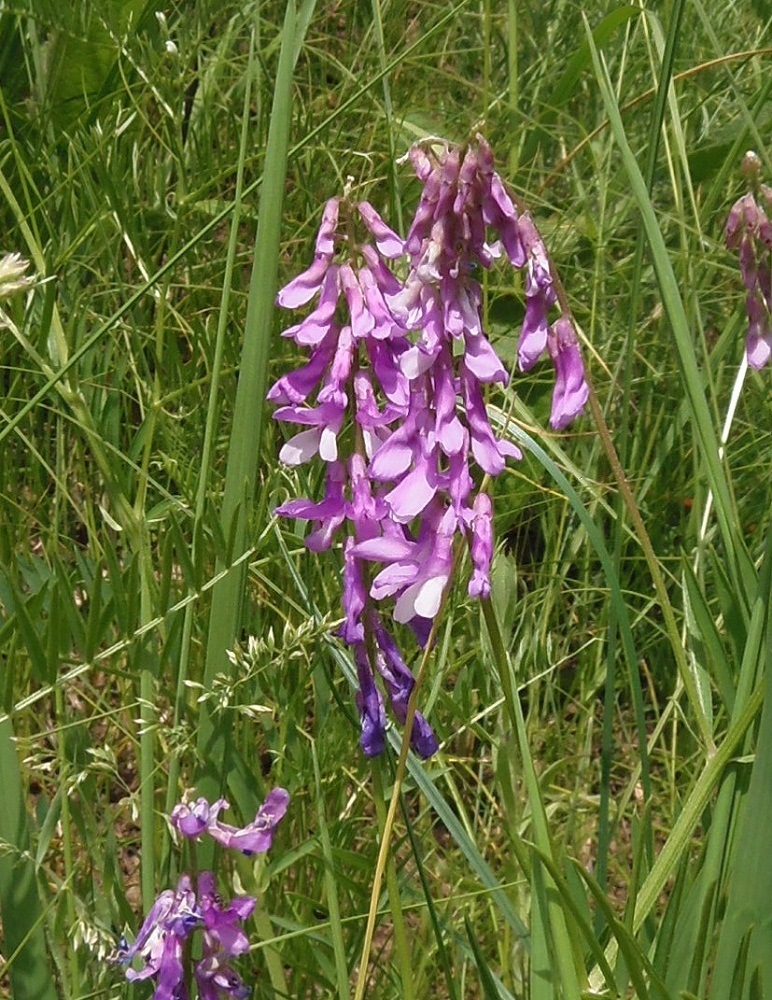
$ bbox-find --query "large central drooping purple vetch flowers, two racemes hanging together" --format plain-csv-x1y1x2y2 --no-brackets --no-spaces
268,135,588,758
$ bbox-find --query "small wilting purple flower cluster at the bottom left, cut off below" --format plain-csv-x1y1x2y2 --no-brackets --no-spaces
116,788,289,1000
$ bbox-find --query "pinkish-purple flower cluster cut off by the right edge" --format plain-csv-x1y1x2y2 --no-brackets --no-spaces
726,153,772,369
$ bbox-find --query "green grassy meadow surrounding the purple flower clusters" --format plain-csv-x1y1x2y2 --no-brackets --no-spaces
0,0,772,1000
